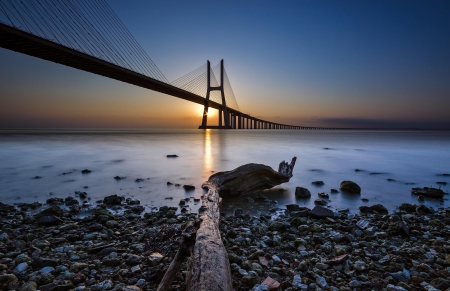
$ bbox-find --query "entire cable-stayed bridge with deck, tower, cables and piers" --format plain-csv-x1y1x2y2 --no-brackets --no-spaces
0,0,307,129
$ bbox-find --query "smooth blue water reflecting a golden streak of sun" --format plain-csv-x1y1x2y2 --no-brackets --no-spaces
0,130,450,211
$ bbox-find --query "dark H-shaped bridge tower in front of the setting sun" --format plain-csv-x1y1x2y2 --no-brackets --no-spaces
198,59,232,129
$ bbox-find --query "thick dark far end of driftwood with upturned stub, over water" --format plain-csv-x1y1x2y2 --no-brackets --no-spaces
205,157,297,197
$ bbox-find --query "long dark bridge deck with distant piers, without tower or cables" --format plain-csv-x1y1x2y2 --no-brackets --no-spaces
0,23,302,129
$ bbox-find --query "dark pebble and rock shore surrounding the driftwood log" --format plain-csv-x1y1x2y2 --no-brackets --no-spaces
0,193,450,291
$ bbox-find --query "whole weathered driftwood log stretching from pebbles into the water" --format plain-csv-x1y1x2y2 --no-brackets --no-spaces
158,157,297,291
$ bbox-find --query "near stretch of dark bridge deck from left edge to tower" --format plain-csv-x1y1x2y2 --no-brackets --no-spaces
0,23,222,109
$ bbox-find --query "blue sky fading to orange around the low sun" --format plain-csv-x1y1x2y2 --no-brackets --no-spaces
0,0,450,129
